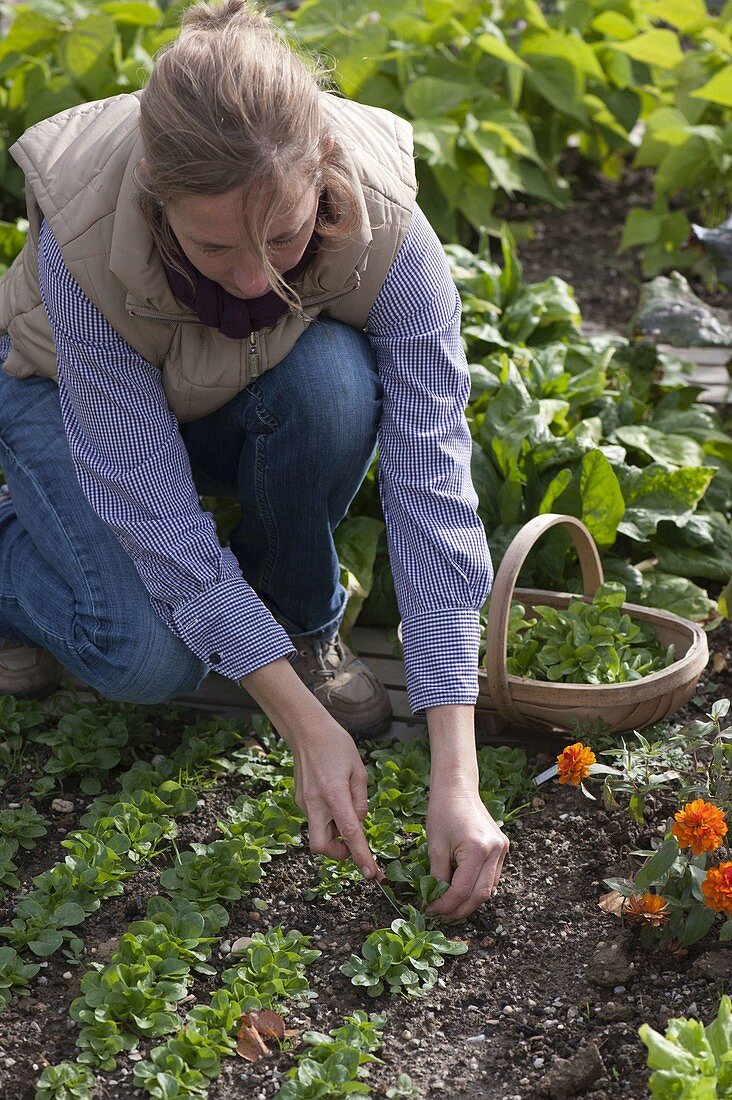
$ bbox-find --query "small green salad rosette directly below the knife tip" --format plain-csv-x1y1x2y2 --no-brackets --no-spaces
340,905,468,998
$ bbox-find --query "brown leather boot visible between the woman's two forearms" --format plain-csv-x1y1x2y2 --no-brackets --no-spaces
292,635,392,741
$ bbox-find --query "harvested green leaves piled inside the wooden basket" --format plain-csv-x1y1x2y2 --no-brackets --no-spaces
479,582,674,684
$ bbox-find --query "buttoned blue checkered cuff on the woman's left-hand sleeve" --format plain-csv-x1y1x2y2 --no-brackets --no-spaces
167,578,297,680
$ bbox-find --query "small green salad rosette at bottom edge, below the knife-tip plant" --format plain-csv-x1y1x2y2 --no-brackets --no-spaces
275,1011,386,1100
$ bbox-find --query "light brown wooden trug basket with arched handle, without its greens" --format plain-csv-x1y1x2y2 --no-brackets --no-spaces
478,514,709,733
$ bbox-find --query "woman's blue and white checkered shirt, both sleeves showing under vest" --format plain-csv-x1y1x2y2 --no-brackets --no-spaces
0,209,492,713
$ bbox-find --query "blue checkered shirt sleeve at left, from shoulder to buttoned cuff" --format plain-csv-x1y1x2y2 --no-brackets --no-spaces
39,222,295,680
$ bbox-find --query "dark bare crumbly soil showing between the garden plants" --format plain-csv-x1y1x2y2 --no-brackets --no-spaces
0,165,732,1100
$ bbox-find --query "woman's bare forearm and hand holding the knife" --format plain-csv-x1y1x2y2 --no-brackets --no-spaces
241,657,380,879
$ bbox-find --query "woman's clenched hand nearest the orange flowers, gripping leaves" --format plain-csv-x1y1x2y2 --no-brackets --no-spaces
426,787,509,921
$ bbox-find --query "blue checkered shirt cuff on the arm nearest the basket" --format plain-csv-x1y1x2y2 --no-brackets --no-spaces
402,608,480,714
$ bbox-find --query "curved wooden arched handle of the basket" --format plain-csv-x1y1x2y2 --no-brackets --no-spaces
485,513,604,725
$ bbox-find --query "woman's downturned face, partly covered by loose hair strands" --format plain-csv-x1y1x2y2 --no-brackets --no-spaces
167,186,319,298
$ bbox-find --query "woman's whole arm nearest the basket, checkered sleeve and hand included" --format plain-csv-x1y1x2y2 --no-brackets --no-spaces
367,209,509,920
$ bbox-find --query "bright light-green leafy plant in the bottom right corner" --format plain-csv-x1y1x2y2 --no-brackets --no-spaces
638,996,732,1100
